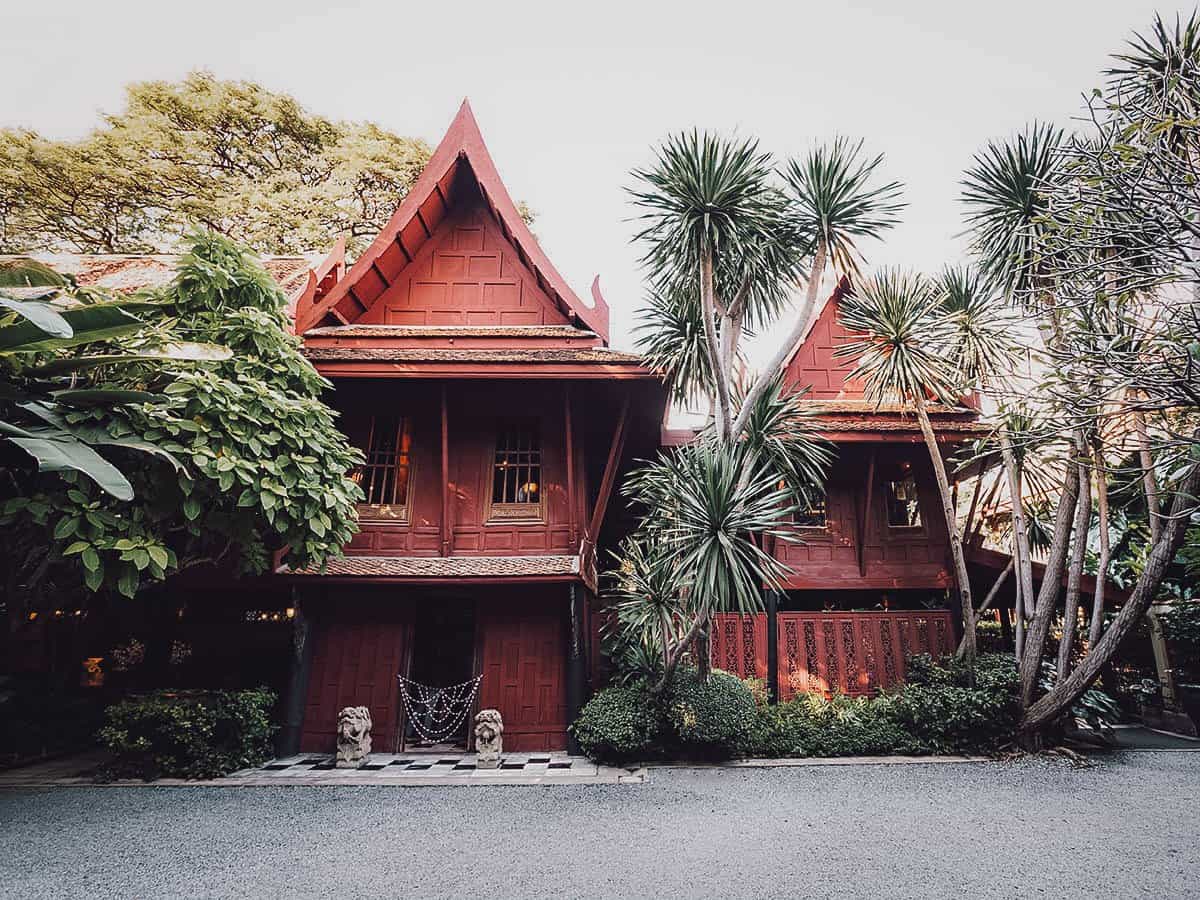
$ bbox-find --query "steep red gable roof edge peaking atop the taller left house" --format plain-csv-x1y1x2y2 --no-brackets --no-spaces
296,101,608,343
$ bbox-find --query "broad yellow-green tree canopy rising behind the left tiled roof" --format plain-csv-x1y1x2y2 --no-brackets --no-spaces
0,72,430,253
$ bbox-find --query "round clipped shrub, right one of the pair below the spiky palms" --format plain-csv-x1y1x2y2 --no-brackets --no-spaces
667,668,757,757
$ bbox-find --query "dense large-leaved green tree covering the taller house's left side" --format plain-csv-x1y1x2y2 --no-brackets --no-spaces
0,233,360,619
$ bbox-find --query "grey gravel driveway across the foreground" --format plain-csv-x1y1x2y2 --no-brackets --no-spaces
0,752,1200,900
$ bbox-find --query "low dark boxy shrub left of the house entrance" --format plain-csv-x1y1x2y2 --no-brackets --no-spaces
98,688,276,781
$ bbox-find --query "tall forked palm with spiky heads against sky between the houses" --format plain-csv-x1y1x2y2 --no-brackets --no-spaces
631,131,904,440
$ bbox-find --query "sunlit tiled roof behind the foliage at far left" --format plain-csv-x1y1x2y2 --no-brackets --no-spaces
0,253,320,294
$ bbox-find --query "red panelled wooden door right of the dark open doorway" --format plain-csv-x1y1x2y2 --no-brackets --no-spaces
476,588,566,751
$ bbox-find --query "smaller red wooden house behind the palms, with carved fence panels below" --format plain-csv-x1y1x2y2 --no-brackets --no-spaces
712,280,989,698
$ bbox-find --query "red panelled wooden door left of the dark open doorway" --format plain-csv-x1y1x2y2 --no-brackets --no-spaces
300,610,412,752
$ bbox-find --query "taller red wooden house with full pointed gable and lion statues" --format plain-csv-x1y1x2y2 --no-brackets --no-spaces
274,103,666,750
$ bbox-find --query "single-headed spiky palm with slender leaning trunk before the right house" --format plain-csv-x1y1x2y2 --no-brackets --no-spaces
836,269,976,667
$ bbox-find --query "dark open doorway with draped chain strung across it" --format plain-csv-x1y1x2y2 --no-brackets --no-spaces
403,596,475,750
